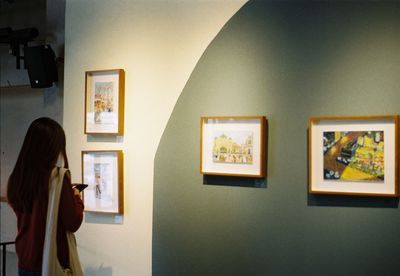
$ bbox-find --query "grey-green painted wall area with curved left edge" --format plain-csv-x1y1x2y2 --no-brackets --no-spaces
152,1,400,275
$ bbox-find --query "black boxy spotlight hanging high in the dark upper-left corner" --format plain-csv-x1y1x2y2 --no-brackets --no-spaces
24,45,58,88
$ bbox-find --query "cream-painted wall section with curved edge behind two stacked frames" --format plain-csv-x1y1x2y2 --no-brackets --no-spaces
64,0,245,275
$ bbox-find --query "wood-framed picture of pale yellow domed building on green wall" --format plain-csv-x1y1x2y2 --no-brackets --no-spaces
200,116,267,177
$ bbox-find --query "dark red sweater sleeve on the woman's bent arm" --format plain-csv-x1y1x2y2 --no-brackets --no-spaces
58,172,83,232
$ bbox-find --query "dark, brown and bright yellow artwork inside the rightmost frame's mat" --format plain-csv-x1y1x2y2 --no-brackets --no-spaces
323,131,385,182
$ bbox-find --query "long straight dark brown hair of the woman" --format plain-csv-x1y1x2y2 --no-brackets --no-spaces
7,117,68,212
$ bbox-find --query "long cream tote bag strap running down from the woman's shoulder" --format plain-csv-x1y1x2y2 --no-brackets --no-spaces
42,167,68,276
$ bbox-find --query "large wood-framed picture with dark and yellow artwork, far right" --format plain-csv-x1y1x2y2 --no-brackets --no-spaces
308,115,399,197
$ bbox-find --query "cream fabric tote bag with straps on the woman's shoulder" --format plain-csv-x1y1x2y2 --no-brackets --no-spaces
42,167,83,276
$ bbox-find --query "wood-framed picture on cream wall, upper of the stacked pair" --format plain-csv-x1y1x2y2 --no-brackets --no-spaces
85,69,125,135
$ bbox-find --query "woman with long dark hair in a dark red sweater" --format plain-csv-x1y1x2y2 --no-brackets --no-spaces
7,118,83,276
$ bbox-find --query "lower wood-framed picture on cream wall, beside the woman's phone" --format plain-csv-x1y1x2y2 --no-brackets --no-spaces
82,150,124,214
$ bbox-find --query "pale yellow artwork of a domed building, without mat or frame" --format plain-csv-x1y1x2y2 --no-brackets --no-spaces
212,131,253,164
